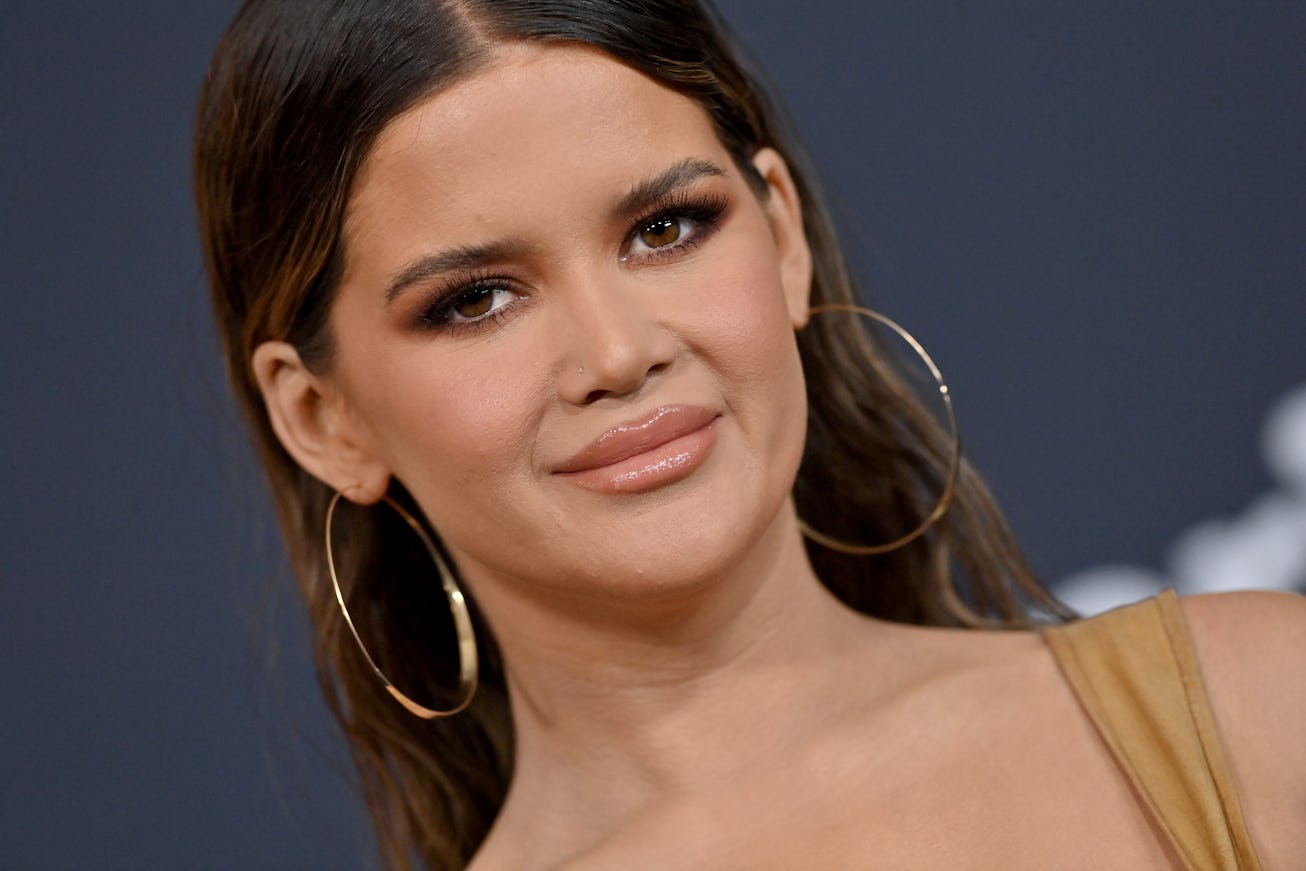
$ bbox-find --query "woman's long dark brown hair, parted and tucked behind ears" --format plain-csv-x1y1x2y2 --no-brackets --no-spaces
195,0,1064,868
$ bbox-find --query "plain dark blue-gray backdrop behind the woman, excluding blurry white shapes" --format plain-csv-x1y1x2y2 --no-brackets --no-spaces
0,0,1306,868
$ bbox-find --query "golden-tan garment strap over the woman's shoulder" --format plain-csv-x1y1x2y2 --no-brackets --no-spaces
1042,590,1262,871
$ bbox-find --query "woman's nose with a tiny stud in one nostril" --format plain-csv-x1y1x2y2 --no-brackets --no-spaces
558,279,678,405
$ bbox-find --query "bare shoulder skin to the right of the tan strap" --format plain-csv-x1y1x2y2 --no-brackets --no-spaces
1182,592,1306,868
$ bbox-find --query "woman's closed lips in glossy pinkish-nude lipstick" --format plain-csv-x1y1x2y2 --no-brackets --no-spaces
554,405,720,492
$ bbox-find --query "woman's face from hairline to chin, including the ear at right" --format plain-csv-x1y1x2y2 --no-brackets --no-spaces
318,46,810,603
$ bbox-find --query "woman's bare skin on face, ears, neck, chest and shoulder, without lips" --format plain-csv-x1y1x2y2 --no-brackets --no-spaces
253,46,1306,871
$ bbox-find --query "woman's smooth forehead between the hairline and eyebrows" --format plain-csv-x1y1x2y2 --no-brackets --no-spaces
345,43,730,252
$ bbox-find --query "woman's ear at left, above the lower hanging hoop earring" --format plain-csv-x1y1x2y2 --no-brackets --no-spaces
251,342,390,504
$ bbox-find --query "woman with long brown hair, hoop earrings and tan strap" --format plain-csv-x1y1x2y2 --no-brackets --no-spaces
196,0,1306,868
